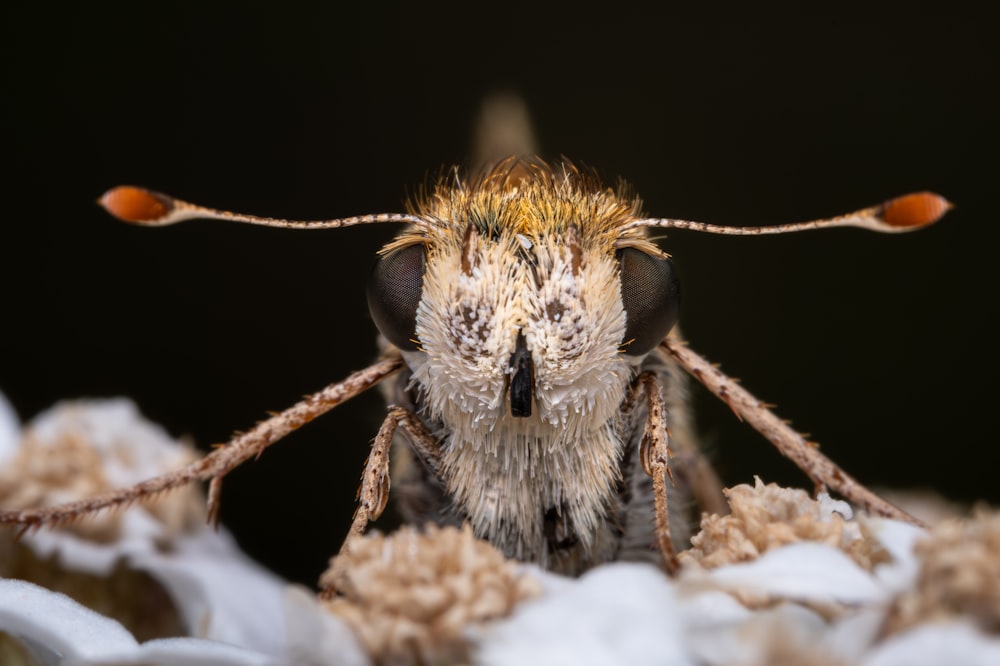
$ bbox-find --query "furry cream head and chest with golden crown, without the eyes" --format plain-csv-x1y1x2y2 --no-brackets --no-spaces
383,160,662,557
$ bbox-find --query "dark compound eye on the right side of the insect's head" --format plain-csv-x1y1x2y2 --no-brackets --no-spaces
615,247,681,356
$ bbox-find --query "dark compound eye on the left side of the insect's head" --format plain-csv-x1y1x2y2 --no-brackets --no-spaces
368,243,425,351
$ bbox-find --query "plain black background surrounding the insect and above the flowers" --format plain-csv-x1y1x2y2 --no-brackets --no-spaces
0,3,1000,583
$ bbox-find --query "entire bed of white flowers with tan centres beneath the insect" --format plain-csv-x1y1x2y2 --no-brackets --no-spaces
0,396,1000,666
